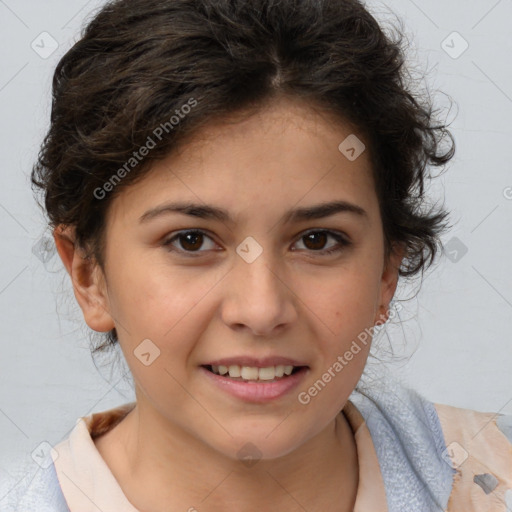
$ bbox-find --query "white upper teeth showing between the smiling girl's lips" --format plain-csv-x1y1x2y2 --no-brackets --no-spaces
202,364,308,383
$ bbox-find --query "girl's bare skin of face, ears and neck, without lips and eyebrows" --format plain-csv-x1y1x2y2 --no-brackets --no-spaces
55,99,403,512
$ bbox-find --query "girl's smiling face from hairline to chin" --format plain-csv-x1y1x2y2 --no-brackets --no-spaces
63,96,400,459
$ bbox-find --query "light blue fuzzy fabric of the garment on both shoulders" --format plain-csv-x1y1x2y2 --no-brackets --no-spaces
0,377,512,512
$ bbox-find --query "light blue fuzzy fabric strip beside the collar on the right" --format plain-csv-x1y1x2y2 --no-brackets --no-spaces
350,377,455,512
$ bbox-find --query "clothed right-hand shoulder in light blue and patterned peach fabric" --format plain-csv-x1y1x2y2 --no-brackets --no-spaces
351,376,512,512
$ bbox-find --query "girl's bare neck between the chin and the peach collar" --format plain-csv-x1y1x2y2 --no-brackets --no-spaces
95,405,359,512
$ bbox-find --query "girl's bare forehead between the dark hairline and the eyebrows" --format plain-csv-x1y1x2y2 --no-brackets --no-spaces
105,97,376,228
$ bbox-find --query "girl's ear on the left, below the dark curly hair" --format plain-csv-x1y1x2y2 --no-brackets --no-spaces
53,225,115,332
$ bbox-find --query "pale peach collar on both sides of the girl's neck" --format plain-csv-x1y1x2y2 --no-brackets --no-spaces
52,401,388,512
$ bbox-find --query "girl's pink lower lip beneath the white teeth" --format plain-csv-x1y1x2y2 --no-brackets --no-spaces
200,366,308,403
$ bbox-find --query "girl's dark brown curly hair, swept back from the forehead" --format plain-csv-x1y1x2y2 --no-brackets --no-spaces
31,0,455,350
